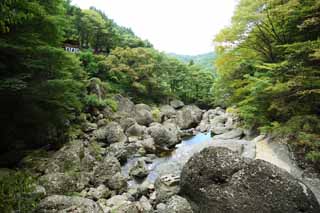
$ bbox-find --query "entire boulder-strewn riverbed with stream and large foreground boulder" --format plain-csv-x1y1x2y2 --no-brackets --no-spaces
4,96,320,213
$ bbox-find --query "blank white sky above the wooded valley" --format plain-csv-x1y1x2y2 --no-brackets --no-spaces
72,0,236,55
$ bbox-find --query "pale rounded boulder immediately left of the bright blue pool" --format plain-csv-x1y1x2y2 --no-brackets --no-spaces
148,123,180,150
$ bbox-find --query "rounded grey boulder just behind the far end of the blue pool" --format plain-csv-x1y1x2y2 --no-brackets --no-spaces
176,105,202,129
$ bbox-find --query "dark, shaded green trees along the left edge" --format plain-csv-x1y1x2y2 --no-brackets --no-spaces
0,0,85,151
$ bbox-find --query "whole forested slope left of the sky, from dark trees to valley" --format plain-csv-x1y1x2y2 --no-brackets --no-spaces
0,0,213,155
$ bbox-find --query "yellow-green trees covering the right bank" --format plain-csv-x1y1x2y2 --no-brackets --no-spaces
213,0,320,166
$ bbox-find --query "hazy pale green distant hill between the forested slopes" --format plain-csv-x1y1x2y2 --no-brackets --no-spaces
168,52,216,70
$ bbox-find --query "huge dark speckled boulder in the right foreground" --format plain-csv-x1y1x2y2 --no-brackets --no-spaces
180,147,320,213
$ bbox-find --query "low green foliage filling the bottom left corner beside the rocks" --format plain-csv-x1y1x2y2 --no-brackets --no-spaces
0,172,39,213
